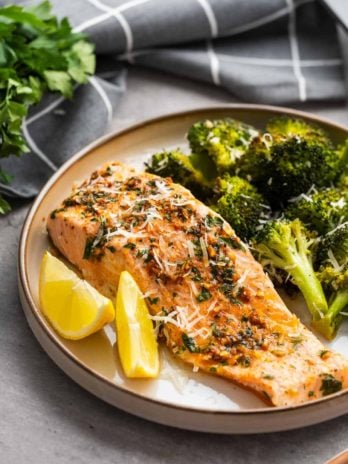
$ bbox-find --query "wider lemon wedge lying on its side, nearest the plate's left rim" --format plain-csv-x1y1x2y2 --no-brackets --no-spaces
39,251,115,340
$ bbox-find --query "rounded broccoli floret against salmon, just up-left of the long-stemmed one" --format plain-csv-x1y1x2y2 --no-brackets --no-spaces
215,174,271,241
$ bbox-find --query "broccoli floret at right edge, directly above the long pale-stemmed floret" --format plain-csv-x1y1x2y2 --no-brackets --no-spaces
285,188,348,235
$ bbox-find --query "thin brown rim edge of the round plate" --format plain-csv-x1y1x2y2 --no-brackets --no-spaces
18,103,348,420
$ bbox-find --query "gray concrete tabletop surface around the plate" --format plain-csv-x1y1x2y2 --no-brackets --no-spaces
0,70,348,464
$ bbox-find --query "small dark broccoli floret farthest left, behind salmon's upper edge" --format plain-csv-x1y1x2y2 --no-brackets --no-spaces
145,150,212,200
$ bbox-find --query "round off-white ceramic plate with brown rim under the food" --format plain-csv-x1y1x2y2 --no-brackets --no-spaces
19,105,348,433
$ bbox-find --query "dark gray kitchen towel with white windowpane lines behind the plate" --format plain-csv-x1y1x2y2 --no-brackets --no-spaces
0,0,347,197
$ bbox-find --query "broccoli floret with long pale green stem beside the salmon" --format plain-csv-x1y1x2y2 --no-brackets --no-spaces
253,219,328,335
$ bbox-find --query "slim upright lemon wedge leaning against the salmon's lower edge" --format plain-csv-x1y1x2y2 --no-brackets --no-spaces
116,271,159,378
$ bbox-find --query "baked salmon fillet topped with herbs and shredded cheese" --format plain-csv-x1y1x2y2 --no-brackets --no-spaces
47,162,348,406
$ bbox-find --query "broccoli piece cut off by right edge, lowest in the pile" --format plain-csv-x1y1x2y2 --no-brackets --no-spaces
315,222,348,338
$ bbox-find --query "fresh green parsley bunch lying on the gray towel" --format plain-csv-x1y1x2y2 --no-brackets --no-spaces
0,1,95,214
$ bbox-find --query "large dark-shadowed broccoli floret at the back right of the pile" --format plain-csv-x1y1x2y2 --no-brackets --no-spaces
237,117,341,206
